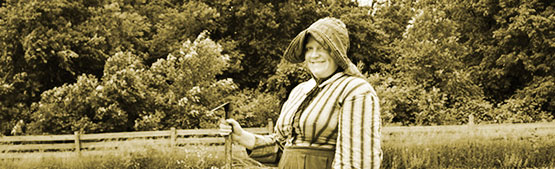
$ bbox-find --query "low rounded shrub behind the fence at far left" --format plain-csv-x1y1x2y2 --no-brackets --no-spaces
29,75,127,134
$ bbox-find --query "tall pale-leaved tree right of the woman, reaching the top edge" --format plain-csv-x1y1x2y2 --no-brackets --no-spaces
382,1,491,124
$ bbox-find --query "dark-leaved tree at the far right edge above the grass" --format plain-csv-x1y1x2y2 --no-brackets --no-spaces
479,1,555,122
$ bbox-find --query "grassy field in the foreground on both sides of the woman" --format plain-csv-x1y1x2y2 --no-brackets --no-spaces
0,123,555,168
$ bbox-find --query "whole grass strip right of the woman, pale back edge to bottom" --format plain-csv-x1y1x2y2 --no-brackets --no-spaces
382,123,555,168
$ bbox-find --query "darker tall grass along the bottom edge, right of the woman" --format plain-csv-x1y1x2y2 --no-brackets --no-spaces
383,135,555,168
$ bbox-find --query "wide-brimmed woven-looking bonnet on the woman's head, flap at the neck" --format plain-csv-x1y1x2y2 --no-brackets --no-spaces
283,17,362,76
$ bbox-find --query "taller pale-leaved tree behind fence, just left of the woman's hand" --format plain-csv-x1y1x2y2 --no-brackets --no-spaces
139,32,237,130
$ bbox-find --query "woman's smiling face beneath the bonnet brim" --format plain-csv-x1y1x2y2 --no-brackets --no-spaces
304,36,337,78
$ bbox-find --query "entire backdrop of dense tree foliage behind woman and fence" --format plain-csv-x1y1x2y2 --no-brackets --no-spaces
0,0,555,135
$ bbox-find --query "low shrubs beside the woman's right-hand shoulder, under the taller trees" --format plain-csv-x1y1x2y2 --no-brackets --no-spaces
367,73,500,125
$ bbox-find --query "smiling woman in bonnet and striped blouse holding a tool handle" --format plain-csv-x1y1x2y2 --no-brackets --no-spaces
220,18,382,169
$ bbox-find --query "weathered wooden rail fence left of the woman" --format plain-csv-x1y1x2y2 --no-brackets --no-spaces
0,121,273,158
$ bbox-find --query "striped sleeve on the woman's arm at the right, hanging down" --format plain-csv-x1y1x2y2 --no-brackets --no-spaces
333,83,382,169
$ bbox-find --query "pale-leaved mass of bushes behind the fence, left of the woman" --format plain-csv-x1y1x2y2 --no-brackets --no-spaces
31,32,237,133
